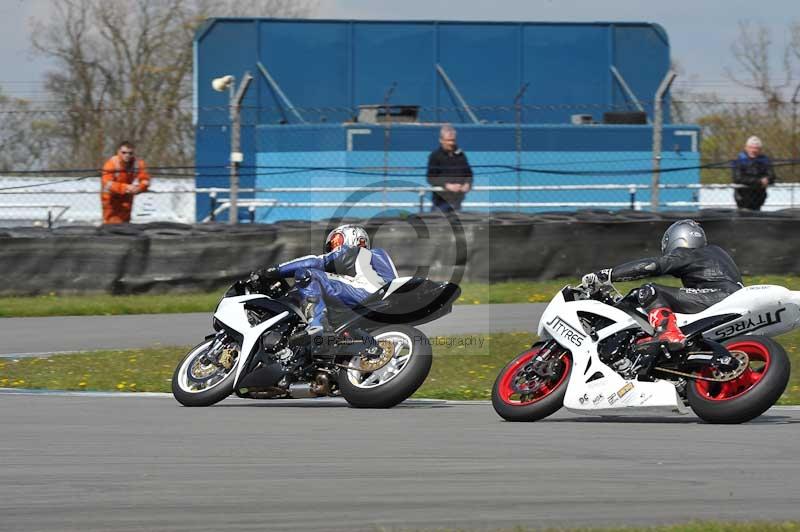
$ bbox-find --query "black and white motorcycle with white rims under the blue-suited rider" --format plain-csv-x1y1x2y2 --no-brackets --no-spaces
172,277,461,408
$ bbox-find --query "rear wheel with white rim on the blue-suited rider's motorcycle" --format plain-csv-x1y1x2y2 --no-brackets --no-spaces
337,325,433,408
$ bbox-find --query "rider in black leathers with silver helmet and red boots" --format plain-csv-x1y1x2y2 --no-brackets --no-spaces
582,220,743,351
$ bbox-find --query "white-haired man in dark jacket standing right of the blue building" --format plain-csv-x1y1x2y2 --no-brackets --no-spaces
733,137,775,211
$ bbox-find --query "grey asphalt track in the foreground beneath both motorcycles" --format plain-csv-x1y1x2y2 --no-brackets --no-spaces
0,394,800,531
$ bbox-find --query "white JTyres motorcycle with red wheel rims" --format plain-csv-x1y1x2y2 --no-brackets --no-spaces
492,285,800,423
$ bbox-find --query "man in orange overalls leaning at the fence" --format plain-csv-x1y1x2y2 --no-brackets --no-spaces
100,140,150,224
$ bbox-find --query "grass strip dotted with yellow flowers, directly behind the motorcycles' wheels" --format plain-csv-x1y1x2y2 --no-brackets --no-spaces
0,331,800,405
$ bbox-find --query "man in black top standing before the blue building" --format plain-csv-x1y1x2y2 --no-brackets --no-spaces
428,125,472,212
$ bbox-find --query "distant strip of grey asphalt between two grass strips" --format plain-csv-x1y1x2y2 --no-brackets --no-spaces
0,303,546,356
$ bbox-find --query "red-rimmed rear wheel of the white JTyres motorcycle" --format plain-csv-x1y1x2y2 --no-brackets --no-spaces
686,336,791,424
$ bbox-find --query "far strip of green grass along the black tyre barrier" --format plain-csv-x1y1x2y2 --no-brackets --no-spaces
0,275,800,318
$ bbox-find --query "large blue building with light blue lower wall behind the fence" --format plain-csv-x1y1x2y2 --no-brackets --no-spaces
194,19,699,221
